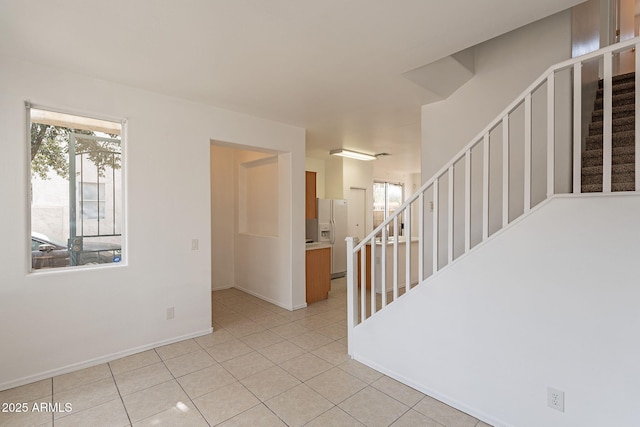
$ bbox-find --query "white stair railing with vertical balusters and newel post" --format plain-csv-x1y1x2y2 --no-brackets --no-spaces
347,38,640,355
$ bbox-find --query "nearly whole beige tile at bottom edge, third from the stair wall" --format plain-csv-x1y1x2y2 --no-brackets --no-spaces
265,384,333,427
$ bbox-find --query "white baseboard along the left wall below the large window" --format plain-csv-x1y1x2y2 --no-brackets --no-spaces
0,328,213,391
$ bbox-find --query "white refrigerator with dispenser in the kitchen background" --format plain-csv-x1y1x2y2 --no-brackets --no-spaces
311,199,348,278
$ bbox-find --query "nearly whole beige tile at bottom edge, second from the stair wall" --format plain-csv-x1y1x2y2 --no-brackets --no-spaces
338,387,409,427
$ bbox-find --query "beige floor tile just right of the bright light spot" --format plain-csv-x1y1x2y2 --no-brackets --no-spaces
194,383,260,425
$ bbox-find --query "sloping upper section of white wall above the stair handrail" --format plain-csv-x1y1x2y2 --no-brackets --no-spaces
422,11,571,182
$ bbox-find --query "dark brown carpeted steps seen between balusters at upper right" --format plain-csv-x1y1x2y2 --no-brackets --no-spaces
582,73,635,193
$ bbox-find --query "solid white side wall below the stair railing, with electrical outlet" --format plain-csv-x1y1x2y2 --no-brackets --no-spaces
352,192,640,426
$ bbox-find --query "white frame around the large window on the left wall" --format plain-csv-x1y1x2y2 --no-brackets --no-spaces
23,101,129,275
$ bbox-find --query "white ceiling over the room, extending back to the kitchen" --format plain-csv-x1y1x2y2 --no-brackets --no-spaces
0,0,582,174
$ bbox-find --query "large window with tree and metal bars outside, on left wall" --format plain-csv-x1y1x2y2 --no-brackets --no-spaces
27,105,124,270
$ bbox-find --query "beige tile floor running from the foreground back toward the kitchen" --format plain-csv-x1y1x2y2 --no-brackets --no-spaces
0,279,487,427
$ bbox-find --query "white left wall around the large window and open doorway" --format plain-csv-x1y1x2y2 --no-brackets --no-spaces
0,57,305,389
